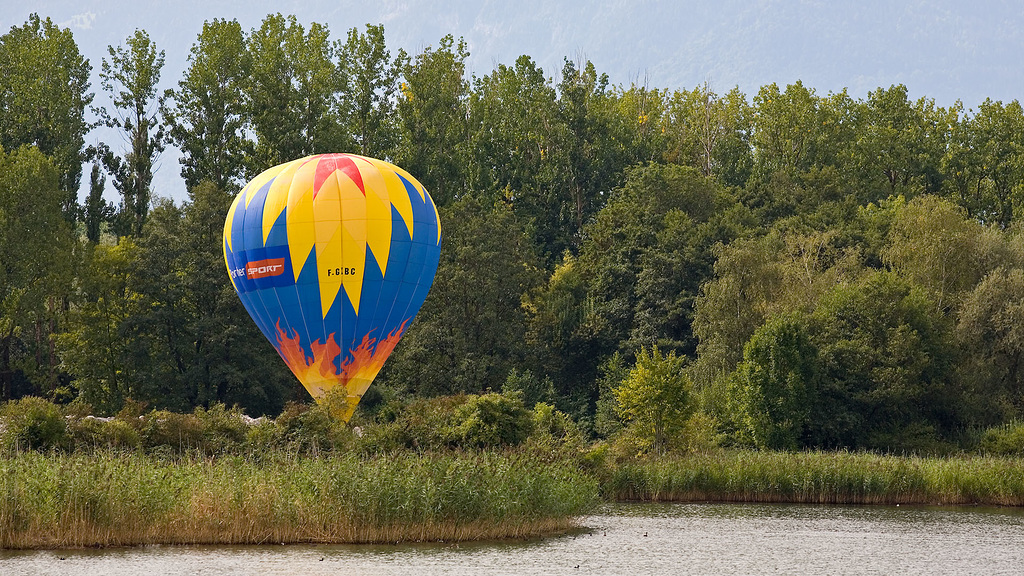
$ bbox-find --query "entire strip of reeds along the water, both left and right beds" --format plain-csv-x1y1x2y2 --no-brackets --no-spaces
0,450,1024,548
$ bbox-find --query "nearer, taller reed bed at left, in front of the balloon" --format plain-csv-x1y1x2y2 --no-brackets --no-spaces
0,452,598,548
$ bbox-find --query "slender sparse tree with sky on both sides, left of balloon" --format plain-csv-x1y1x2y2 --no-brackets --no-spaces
99,30,165,236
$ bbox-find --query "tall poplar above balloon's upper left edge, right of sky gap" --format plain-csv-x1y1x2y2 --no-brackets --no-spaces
161,19,251,191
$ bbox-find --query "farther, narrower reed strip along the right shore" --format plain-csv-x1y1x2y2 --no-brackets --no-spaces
602,451,1024,506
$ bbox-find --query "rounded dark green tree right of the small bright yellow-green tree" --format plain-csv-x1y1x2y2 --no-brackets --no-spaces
730,317,818,450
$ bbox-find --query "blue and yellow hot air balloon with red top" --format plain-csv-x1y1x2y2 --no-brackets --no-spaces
224,154,441,422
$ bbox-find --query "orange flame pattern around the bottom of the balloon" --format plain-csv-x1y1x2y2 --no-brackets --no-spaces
276,320,409,422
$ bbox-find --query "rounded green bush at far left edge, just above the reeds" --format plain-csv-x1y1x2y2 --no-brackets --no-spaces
0,397,71,450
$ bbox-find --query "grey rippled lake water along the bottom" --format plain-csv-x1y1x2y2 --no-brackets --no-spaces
0,504,1024,576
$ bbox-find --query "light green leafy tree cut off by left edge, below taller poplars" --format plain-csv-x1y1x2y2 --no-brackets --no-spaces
0,146,75,399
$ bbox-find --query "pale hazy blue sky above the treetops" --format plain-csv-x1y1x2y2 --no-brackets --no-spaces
0,0,1024,200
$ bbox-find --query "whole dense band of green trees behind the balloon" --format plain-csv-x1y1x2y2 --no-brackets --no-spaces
0,14,1024,450
